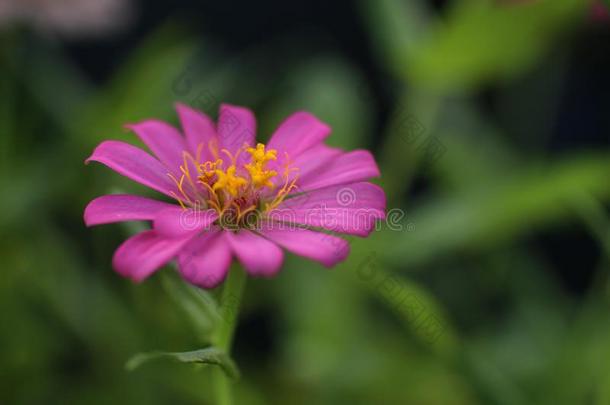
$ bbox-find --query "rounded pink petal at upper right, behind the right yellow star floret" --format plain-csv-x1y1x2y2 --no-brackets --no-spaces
269,111,330,157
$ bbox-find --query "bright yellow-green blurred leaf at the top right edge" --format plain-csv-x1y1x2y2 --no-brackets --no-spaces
402,0,588,90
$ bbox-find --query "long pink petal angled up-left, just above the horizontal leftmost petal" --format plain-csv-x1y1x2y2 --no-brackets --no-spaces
85,141,178,196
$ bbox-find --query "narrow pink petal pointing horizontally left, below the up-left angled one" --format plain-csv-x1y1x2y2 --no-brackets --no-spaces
84,194,173,226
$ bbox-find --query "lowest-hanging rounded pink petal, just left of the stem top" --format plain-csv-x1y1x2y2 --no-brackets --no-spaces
178,229,231,288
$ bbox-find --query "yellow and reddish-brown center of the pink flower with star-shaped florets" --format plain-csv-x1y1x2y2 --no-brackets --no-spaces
168,141,298,229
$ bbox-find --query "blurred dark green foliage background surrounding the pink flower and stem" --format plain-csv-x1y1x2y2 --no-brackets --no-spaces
0,0,610,405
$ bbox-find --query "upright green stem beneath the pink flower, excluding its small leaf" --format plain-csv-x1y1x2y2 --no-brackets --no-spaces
212,266,246,405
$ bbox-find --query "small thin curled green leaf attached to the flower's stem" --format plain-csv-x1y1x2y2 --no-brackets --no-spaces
125,347,239,379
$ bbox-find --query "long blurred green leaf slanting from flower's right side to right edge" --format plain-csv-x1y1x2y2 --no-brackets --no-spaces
370,155,610,267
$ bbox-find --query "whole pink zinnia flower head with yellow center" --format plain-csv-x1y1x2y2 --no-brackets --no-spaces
84,104,385,288
